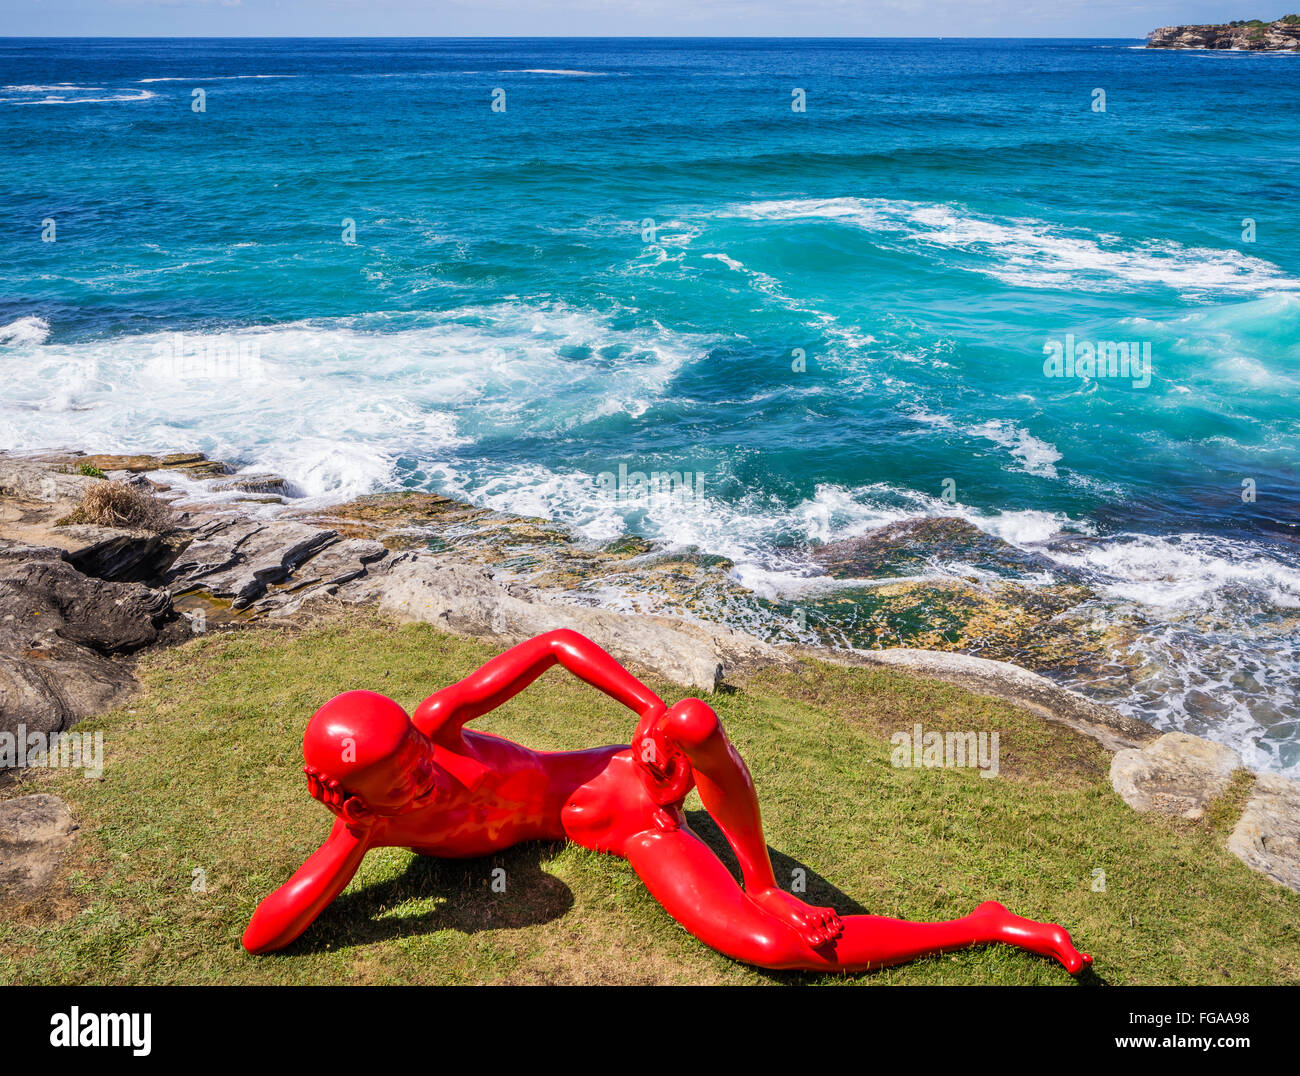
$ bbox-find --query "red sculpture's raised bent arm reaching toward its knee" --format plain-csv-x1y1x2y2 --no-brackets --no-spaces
413,628,666,737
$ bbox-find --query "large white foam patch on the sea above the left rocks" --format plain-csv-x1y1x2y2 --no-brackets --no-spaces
0,303,710,498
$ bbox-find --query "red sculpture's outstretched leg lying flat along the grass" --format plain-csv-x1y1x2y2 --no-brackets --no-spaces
625,829,1091,973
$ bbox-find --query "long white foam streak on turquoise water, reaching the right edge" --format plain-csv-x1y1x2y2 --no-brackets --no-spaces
727,198,1300,292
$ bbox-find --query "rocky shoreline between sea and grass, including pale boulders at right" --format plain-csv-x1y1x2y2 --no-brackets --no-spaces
0,454,1300,890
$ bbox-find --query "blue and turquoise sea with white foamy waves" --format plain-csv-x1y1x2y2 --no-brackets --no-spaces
0,39,1300,773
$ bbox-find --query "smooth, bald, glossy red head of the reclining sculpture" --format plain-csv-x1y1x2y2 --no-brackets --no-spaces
303,691,438,821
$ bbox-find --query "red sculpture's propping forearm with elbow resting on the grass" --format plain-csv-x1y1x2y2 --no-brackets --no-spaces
243,819,371,953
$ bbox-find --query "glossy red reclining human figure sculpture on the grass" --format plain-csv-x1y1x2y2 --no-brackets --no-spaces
243,630,1092,973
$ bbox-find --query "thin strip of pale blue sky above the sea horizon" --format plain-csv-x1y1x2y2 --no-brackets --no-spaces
0,0,1284,38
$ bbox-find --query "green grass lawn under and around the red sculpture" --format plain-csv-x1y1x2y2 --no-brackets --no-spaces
0,621,1300,984
